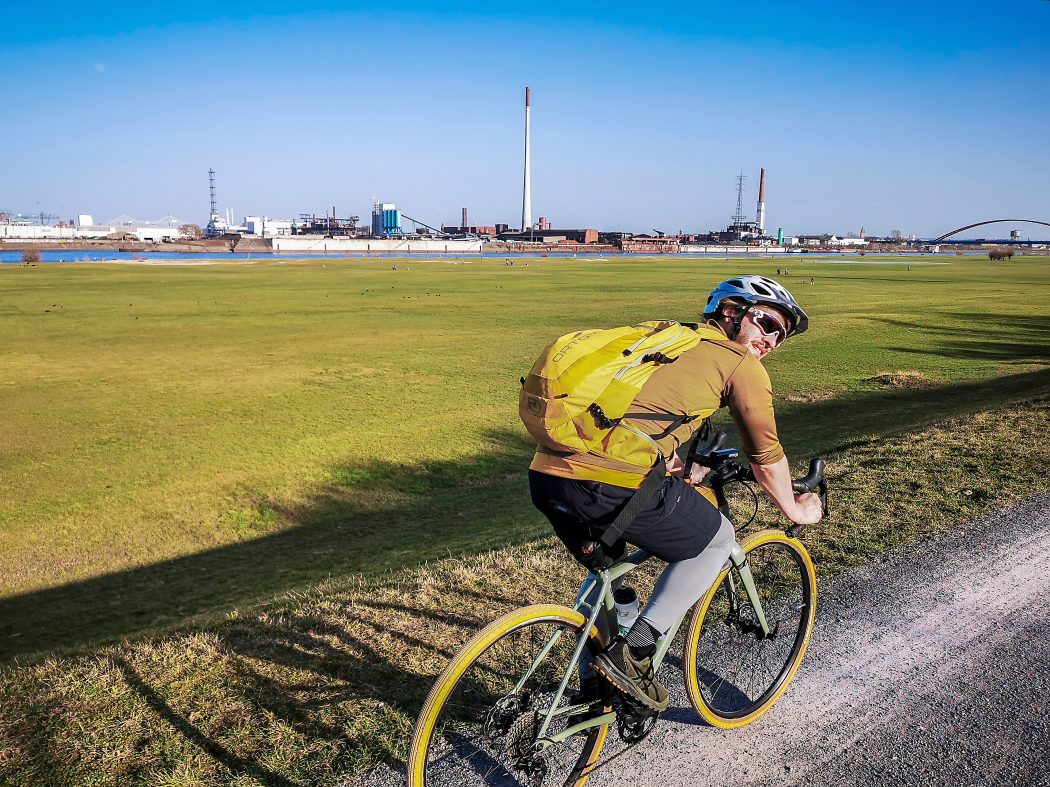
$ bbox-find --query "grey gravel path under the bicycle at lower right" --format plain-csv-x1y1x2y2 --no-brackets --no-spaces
354,493,1050,787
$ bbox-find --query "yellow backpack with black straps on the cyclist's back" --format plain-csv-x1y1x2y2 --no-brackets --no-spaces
518,320,726,471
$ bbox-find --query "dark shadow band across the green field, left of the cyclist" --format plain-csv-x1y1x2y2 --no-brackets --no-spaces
0,430,546,661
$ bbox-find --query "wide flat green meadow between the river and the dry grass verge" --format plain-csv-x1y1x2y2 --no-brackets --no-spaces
0,258,1050,659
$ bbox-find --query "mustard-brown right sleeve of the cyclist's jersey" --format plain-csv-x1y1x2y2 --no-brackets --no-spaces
725,354,784,465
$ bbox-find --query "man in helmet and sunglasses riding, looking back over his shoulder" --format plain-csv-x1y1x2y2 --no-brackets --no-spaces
529,276,822,710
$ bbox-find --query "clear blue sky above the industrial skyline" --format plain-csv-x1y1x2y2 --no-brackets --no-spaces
0,0,1050,237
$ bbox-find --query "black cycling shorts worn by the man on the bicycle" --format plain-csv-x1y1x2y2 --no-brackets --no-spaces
528,470,721,565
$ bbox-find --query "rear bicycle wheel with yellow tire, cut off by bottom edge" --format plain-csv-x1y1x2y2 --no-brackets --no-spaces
407,604,608,787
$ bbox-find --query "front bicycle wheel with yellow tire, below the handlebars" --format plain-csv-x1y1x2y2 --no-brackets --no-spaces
683,530,817,728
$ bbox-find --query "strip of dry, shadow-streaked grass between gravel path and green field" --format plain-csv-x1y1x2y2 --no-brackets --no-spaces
0,399,1050,787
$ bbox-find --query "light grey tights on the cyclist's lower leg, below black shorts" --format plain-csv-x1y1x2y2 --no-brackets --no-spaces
578,516,736,677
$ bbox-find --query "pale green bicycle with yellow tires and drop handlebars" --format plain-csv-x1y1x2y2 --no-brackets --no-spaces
407,432,827,787
